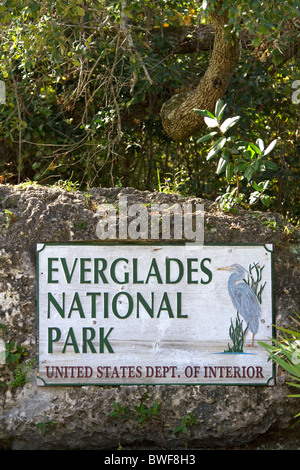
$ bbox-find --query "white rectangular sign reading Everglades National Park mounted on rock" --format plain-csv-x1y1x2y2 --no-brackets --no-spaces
37,243,273,386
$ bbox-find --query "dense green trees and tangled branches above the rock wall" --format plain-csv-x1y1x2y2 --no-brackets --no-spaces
0,0,300,220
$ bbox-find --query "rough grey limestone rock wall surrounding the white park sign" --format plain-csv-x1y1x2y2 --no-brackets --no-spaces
0,185,300,449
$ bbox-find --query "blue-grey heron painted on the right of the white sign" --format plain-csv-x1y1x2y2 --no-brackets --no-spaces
218,264,260,347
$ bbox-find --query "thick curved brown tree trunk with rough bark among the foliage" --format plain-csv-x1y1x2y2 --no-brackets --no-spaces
160,7,240,140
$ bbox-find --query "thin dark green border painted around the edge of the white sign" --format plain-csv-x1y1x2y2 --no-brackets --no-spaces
36,244,276,387
